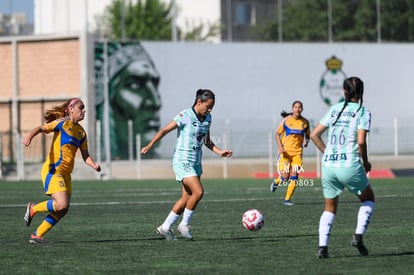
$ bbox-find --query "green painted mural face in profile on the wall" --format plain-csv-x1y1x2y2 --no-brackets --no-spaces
95,42,161,159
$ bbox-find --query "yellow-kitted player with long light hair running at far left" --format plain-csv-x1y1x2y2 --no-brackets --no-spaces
23,98,101,244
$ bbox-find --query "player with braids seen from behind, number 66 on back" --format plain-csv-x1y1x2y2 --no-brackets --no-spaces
311,77,375,258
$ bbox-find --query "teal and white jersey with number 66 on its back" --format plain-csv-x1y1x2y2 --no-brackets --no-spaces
320,102,371,167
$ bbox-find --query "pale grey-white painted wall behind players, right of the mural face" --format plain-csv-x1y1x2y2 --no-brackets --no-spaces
142,42,414,156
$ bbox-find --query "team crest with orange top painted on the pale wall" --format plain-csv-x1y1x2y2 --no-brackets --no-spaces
319,55,346,106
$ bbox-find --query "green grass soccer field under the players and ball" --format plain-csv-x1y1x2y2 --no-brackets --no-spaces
0,178,414,274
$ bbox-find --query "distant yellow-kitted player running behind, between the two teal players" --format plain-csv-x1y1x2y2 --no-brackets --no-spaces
270,100,310,206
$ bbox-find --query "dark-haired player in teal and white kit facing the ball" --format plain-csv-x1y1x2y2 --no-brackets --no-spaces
141,89,232,240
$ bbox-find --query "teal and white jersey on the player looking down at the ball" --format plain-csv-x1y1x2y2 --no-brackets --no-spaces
173,108,211,165
